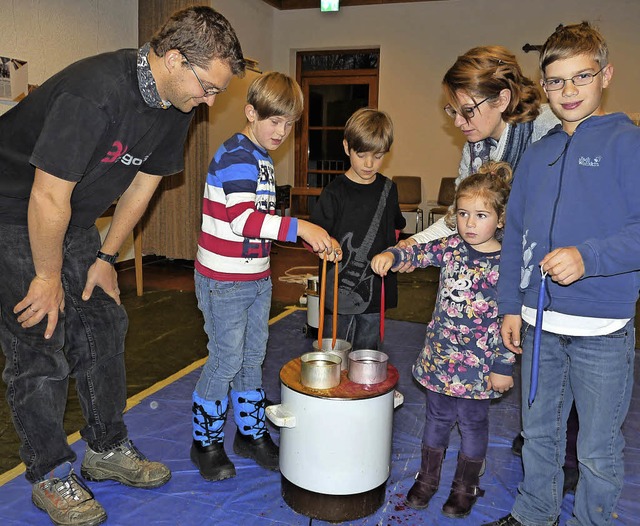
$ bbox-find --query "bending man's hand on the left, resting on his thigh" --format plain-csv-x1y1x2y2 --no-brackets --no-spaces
13,276,64,340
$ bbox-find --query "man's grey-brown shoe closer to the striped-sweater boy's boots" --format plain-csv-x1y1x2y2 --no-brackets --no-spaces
80,440,171,488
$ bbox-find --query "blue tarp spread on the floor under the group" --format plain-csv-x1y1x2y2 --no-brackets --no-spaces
0,311,640,526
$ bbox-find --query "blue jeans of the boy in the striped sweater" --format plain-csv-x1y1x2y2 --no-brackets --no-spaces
195,271,272,401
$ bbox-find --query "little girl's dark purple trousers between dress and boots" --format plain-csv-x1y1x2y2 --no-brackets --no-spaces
422,391,491,459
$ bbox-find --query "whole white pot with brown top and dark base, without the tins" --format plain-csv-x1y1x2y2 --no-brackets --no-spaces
267,358,402,522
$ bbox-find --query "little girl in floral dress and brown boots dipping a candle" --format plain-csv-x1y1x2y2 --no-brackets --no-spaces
371,161,515,517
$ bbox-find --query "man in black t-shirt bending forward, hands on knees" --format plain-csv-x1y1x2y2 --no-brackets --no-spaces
0,6,244,525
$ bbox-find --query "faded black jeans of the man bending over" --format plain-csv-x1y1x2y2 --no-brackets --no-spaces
0,224,128,482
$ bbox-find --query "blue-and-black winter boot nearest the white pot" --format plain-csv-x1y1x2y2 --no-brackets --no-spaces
231,389,280,471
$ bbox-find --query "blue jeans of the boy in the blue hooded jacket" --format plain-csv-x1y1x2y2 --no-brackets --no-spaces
512,319,635,526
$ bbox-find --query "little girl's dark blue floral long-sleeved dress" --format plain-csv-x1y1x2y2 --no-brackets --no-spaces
388,234,515,399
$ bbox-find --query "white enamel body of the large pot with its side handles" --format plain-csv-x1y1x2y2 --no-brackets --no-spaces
266,384,404,495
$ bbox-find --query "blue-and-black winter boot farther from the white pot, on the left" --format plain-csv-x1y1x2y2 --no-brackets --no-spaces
190,391,236,481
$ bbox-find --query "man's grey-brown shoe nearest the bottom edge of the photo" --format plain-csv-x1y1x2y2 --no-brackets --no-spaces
31,462,107,526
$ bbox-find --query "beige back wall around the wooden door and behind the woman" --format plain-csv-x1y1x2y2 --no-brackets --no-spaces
272,0,640,205
